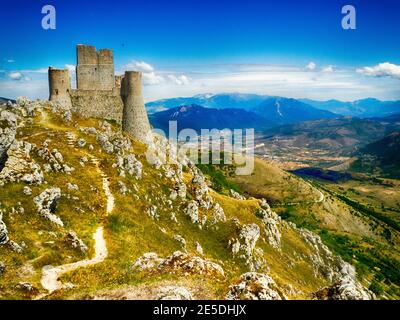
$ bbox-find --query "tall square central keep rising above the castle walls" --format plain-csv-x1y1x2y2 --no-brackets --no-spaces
76,45,115,90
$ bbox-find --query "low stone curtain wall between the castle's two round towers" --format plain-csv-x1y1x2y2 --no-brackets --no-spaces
71,89,123,124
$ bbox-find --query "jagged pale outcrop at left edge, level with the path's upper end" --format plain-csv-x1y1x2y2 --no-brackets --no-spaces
0,140,44,184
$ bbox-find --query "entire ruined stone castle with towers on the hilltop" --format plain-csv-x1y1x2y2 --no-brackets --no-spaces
49,45,151,142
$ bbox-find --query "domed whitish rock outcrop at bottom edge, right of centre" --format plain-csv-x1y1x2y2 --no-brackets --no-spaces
226,272,287,300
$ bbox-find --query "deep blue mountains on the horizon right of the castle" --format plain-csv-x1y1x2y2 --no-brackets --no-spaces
148,95,340,130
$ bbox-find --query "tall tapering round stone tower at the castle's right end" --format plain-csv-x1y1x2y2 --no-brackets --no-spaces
121,71,151,142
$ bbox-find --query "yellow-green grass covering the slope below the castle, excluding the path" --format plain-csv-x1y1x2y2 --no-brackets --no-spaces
0,102,394,299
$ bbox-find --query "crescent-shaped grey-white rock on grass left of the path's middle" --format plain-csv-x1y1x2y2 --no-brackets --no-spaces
33,188,64,227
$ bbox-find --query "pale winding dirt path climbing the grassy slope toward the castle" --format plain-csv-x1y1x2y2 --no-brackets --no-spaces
40,155,114,298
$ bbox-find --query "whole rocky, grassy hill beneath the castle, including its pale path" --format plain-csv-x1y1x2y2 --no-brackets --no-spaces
0,99,384,299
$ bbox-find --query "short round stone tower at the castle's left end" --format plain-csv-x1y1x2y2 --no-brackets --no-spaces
49,67,71,108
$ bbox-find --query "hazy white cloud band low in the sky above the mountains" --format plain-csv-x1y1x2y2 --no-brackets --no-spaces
0,60,400,101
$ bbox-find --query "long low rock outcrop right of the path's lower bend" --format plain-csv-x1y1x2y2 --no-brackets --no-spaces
133,251,225,277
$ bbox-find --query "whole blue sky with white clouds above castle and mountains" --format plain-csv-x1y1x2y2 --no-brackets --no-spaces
0,0,400,101
